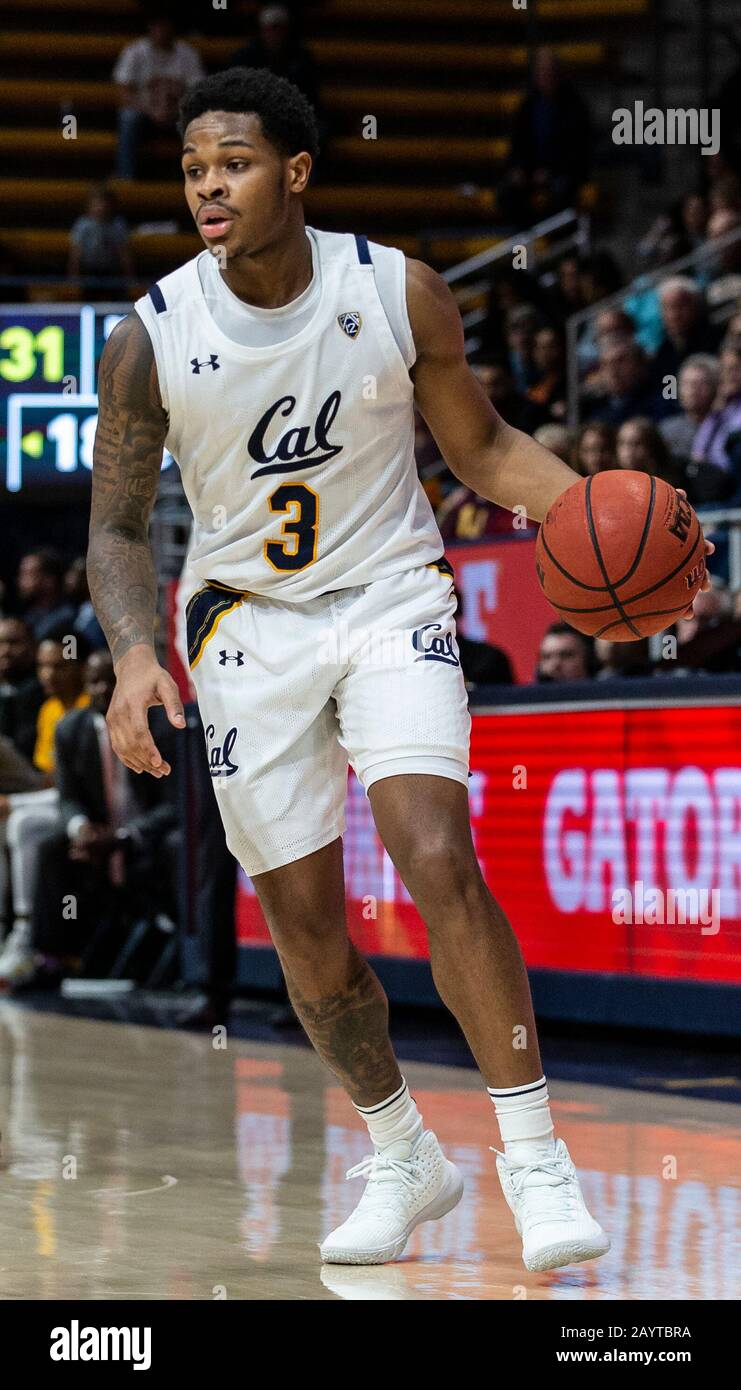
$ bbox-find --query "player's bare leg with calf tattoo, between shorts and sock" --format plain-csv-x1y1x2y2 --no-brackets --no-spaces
253,840,402,1105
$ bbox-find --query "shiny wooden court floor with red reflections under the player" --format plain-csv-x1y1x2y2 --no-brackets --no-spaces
0,1002,741,1301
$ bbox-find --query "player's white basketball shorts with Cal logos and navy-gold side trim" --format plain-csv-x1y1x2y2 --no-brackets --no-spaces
186,560,471,876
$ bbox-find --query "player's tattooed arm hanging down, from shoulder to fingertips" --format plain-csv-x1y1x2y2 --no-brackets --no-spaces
88,313,185,777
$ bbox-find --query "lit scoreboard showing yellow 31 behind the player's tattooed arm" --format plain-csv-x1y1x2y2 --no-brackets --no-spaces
0,304,171,503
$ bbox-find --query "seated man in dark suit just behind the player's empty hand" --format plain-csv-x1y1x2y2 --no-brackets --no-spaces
0,652,177,984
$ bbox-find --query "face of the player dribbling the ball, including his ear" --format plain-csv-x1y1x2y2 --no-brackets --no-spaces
182,111,311,265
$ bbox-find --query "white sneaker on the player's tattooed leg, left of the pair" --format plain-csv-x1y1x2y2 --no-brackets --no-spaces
320,1130,463,1265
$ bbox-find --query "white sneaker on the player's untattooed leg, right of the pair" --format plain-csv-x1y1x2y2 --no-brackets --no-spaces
492,1138,610,1269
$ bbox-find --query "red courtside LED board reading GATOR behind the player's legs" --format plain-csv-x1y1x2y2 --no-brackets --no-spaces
238,706,741,981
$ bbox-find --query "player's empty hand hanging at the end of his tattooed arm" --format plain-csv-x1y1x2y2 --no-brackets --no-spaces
106,642,185,777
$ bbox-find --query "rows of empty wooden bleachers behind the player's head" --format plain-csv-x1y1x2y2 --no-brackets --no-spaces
0,0,651,299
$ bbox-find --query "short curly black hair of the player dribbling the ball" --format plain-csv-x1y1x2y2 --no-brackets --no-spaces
178,68,318,158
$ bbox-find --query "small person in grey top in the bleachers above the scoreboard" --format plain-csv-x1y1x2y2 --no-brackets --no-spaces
67,183,133,299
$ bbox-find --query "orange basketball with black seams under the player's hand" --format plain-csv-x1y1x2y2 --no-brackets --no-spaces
535,468,705,642
